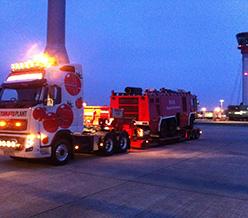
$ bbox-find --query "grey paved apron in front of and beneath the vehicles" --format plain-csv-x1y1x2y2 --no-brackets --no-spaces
0,125,248,218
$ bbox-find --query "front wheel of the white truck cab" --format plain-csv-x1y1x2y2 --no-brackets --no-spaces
52,139,72,165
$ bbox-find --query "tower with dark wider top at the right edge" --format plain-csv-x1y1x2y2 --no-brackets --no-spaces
236,32,248,105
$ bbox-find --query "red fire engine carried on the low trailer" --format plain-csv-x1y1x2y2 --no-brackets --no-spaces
86,87,201,148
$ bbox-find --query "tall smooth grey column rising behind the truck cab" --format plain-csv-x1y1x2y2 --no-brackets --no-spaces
45,0,70,64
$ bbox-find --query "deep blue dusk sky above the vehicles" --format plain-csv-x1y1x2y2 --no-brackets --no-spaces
0,0,248,109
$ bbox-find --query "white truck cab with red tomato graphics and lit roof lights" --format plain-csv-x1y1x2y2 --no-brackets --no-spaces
0,55,83,163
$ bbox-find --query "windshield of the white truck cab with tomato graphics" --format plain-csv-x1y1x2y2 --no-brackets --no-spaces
0,86,42,108
